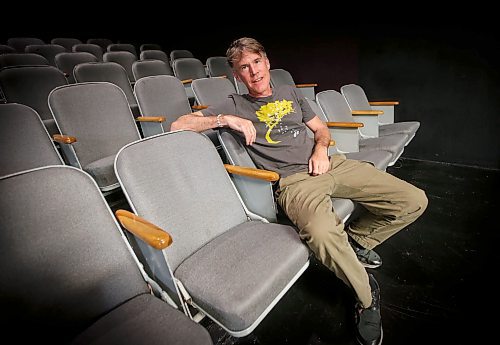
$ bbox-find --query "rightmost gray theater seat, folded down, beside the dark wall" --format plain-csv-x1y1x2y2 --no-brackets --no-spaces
340,84,420,145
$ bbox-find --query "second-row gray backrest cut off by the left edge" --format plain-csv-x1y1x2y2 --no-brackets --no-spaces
0,103,64,176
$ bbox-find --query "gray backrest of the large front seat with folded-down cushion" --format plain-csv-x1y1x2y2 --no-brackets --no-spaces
115,131,247,271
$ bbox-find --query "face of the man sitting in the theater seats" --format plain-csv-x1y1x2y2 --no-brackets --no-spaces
233,51,272,97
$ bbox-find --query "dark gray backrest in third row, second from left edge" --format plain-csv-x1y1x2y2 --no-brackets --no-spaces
73,62,137,107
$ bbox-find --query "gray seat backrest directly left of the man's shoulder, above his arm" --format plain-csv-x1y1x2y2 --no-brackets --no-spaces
191,77,236,105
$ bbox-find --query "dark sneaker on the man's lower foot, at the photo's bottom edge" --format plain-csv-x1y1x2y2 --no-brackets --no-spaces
356,274,384,345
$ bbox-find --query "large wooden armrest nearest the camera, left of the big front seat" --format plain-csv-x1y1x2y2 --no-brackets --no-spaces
115,210,172,249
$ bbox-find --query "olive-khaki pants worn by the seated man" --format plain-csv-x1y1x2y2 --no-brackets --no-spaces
278,155,427,307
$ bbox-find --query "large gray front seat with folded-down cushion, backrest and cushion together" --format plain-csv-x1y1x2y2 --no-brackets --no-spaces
115,131,309,336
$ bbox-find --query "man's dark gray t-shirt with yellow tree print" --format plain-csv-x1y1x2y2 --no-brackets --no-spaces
201,85,315,177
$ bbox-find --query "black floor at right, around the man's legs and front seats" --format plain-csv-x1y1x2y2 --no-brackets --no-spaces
196,159,500,345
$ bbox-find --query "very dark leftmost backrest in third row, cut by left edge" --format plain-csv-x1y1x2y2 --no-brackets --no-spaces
0,66,68,135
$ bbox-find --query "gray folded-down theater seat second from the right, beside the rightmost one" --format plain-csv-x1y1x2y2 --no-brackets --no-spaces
316,90,408,165
